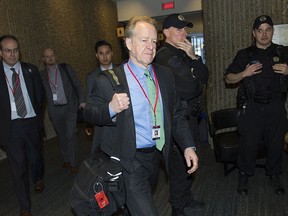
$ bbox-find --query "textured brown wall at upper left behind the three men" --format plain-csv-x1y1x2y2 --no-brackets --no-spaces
0,0,121,82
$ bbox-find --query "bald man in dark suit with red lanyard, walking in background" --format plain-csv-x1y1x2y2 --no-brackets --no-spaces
40,48,85,175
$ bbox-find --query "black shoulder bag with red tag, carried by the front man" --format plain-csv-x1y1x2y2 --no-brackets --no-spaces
69,70,126,216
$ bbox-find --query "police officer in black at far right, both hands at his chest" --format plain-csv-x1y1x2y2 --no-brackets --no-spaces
225,15,288,195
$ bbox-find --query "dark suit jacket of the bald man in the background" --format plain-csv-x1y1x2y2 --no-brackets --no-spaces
40,64,85,118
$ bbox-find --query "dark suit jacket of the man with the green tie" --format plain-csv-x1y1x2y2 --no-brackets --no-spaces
85,61,194,172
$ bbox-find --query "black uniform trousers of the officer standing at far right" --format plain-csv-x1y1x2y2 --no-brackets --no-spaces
238,99,288,176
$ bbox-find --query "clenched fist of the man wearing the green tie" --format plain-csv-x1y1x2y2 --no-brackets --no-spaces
109,93,130,113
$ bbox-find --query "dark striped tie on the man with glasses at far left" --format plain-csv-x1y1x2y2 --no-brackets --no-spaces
10,68,27,118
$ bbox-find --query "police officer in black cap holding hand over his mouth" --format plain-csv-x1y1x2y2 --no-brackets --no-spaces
155,14,208,216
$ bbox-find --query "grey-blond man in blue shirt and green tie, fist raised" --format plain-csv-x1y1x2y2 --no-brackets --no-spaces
85,16,198,216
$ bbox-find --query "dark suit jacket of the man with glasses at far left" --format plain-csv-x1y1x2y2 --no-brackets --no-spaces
0,61,45,145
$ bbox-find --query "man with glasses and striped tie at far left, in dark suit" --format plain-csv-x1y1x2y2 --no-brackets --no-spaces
0,35,45,216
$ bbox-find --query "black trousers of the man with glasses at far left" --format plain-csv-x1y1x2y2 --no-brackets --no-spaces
5,117,44,210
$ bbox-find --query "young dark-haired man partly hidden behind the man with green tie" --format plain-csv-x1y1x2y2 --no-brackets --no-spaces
85,40,114,136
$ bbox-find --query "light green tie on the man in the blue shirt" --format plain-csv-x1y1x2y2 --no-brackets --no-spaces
144,70,165,151
